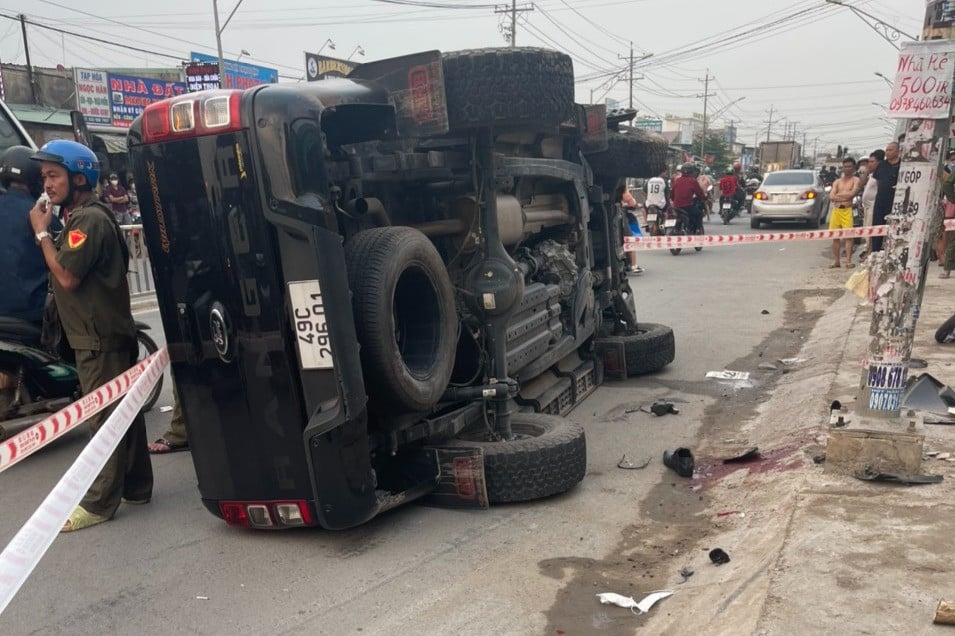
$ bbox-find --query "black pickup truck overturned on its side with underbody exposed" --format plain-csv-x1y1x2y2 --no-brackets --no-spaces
129,48,674,529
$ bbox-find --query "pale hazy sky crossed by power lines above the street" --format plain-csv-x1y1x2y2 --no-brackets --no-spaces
0,0,925,153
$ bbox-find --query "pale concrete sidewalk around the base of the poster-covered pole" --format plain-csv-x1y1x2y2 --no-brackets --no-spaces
641,263,955,635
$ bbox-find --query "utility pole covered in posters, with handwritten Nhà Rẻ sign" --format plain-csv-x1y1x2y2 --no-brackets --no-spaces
857,22,955,424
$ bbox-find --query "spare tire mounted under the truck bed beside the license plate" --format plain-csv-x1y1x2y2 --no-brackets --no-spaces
345,227,458,411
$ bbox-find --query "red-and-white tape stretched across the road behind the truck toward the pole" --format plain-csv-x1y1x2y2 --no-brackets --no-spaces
623,219,955,252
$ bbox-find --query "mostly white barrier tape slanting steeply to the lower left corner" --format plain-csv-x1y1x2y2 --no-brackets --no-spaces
0,347,169,613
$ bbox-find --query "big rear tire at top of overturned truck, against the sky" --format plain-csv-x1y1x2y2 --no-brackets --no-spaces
442,47,574,130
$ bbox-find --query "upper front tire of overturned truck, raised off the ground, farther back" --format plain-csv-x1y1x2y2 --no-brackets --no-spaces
587,129,667,179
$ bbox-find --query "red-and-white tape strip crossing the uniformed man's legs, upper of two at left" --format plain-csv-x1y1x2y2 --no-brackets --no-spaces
0,354,156,473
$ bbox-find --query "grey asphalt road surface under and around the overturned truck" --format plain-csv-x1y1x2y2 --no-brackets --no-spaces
0,216,829,636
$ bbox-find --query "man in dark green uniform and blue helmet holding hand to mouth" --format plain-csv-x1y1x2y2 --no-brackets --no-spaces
30,139,153,532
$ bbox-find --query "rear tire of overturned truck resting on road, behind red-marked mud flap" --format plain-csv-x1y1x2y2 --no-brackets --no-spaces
445,413,587,503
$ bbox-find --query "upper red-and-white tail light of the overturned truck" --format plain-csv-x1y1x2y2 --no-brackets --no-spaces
143,90,242,143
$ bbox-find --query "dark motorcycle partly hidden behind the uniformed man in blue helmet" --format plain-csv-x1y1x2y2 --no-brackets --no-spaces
0,318,163,439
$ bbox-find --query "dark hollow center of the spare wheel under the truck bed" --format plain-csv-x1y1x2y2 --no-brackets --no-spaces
393,266,441,379
